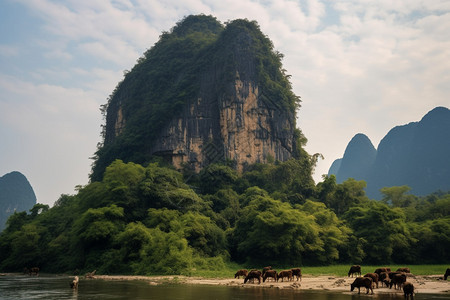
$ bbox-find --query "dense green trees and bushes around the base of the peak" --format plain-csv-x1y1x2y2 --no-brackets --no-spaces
0,160,450,275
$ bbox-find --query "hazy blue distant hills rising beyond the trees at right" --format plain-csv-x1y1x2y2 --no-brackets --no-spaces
328,107,450,199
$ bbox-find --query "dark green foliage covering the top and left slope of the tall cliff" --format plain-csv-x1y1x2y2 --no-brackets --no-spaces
91,15,301,181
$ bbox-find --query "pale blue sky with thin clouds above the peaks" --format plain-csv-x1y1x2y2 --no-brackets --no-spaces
0,0,450,206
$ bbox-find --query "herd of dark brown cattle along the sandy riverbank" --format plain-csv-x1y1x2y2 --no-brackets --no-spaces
234,265,450,299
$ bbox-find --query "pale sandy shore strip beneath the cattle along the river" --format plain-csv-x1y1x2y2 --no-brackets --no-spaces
95,275,450,296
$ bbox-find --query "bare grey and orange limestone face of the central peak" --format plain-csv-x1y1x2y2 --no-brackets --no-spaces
150,72,294,171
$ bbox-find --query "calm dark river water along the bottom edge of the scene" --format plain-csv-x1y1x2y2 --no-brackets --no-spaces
0,275,450,300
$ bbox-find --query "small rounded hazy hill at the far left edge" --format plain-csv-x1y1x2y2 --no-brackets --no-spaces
0,171,36,231
